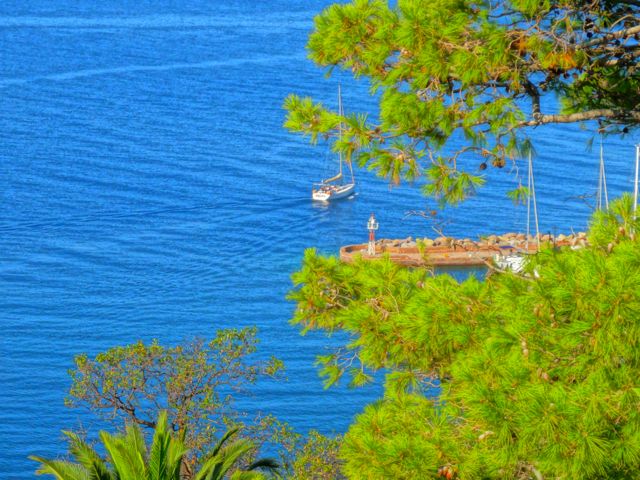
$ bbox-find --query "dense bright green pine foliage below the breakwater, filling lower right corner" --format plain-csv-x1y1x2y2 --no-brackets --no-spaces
291,196,640,479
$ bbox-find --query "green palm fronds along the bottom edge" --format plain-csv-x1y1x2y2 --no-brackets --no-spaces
30,412,278,480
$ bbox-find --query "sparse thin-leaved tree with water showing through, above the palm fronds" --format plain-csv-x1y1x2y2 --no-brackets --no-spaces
67,328,283,457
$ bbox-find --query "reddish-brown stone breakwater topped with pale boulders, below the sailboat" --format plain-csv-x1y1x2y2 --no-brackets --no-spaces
340,232,587,266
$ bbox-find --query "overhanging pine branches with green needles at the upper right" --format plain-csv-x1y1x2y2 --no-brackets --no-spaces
285,0,640,203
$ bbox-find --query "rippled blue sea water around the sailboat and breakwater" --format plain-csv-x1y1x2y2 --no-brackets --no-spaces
0,0,636,478
